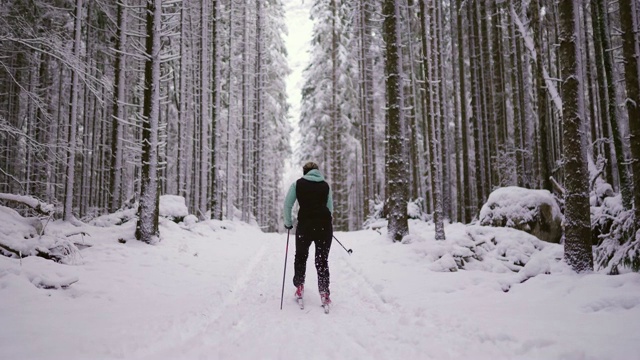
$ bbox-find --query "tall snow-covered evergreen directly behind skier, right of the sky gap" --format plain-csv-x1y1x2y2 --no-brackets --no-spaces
297,0,359,230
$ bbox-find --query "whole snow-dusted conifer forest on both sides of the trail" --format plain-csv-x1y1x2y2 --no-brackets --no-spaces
0,0,640,273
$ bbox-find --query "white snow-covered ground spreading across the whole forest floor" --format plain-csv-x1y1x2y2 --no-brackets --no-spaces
0,207,640,359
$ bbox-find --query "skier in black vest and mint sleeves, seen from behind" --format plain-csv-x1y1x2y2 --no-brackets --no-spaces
284,162,333,312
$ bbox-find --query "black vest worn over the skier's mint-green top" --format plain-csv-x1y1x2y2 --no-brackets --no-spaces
296,178,331,225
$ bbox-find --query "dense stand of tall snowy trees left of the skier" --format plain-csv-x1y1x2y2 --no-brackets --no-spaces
0,0,290,233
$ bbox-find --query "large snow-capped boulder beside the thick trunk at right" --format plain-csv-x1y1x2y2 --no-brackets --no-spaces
480,186,562,243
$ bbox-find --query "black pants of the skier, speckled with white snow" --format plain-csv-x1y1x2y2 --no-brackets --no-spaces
293,224,333,294
